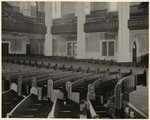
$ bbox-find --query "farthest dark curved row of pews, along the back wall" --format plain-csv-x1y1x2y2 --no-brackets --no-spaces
2,54,148,67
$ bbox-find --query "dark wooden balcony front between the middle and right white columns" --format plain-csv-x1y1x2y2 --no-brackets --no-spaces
84,19,118,33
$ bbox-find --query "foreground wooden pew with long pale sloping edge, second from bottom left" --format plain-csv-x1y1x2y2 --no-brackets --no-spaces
7,72,85,117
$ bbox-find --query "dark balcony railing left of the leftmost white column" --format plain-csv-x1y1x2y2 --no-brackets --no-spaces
2,18,46,34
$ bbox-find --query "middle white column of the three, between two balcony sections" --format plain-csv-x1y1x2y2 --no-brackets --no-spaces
76,2,85,59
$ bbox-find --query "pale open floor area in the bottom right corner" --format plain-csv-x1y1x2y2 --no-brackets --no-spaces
130,86,149,115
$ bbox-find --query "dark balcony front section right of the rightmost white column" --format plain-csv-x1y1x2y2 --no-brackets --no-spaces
128,15,149,30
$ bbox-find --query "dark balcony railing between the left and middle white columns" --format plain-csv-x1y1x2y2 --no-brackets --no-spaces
51,23,77,34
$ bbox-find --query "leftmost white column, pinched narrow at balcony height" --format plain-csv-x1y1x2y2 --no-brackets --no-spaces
44,2,53,56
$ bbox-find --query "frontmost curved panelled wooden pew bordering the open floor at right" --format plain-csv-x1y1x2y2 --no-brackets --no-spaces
115,74,148,119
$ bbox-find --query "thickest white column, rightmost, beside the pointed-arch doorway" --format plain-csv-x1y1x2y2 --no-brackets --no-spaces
118,2,130,62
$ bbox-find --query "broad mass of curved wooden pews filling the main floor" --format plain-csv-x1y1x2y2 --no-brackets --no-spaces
2,58,147,119
